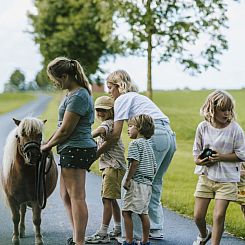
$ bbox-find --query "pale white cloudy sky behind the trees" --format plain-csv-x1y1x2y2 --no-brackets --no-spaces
0,0,245,92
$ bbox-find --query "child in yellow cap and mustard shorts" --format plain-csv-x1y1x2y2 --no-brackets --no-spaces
85,96,126,244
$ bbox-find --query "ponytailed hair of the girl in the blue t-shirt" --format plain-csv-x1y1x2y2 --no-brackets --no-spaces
47,57,91,94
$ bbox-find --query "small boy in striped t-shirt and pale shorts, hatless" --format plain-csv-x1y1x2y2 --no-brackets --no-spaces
122,114,156,245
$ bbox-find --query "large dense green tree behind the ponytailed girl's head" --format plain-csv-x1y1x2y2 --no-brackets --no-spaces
28,0,119,84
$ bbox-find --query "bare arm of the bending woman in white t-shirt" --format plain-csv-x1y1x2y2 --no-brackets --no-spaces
97,120,124,158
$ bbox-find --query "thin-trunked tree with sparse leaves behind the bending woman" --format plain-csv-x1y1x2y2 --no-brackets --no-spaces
114,0,234,98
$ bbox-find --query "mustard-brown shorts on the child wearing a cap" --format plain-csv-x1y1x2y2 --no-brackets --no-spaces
101,167,125,199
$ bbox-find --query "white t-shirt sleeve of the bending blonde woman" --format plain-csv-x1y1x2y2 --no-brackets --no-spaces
114,94,131,122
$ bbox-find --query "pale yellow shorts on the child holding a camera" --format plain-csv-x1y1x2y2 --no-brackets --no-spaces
194,175,237,201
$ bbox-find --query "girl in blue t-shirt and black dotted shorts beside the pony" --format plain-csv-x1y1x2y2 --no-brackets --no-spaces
41,57,97,245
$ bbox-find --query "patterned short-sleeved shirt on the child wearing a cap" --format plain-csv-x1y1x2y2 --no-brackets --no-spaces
98,119,126,170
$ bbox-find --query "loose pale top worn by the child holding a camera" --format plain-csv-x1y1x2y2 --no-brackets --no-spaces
193,121,245,182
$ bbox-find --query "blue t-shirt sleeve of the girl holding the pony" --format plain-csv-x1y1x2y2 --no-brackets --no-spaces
66,94,89,116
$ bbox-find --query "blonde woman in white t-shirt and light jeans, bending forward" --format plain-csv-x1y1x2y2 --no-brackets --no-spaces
97,70,176,239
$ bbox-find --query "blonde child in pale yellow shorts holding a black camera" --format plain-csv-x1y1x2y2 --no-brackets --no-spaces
193,90,245,245
